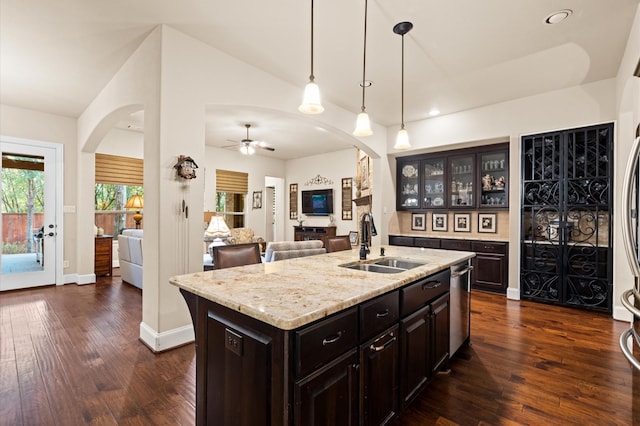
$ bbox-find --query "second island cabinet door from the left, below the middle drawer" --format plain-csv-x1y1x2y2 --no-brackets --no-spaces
360,325,398,425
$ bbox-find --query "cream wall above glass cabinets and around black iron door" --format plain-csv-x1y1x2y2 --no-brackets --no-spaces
383,79,618,299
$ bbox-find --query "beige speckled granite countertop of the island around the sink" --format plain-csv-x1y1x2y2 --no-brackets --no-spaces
169,246,475,330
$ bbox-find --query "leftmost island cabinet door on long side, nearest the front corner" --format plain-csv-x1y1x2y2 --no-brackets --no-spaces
296,348,358,426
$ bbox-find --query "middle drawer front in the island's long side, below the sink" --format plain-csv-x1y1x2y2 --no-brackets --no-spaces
360,291,400,341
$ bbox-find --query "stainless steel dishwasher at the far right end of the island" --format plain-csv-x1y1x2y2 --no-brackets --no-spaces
449,259,473,357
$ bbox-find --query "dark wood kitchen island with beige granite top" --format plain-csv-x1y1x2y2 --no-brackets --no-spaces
170,246,474,425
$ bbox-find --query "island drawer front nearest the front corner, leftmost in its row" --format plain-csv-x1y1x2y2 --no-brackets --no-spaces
295,307,358,378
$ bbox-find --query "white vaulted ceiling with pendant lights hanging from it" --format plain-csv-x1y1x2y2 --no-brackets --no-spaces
0,0,640,158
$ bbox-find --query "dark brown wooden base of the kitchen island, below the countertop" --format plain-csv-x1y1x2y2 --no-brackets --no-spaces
181,269,450,425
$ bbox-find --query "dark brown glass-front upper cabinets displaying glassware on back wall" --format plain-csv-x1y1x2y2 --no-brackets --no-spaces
396,143,509,211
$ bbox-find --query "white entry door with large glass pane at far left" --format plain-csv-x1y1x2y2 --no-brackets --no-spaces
0,139,57,291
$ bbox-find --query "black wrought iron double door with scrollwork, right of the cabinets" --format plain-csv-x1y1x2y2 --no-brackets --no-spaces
520,124,613,312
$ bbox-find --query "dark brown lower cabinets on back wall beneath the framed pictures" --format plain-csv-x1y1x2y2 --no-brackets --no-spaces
389,235,509,294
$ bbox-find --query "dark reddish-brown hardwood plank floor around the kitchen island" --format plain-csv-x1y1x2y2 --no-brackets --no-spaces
0,270,640,426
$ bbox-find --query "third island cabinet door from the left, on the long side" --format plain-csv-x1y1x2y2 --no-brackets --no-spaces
400,306,431,406
